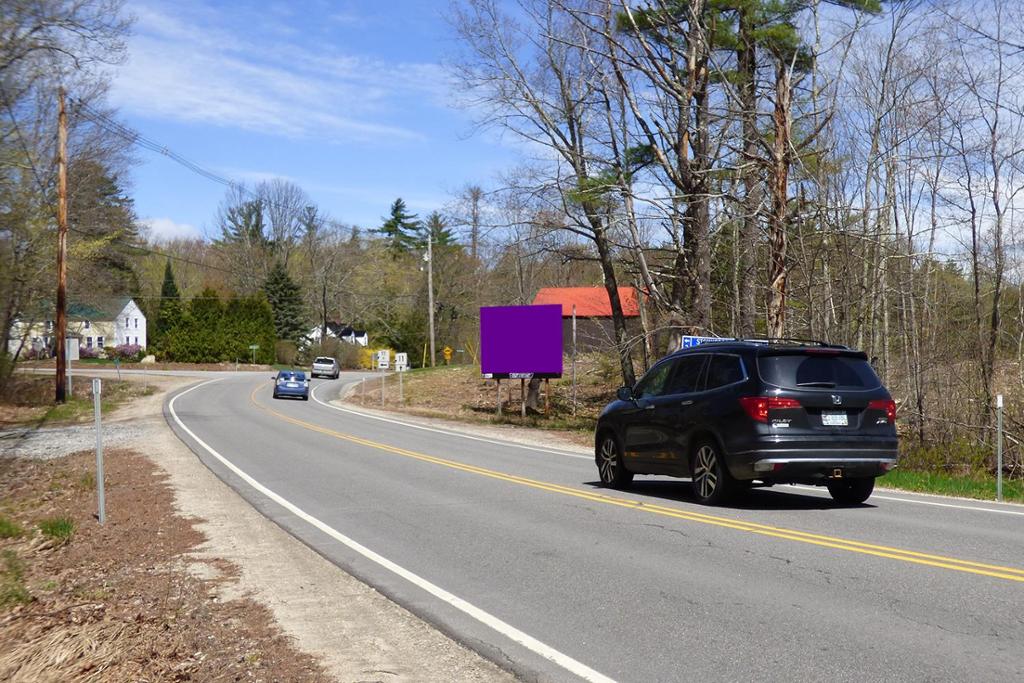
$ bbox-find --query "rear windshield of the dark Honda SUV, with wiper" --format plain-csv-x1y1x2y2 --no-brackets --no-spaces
758,353,882,389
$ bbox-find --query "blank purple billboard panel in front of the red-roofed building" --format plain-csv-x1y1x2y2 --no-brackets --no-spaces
480,304,562,379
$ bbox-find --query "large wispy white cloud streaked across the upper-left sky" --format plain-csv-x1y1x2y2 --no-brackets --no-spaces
112,5,447,142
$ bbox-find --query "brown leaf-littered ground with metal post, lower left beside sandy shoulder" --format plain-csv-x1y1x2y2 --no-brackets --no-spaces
0,450,325,681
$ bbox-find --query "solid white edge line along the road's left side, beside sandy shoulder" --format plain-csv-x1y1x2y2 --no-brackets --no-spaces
167,378,613,683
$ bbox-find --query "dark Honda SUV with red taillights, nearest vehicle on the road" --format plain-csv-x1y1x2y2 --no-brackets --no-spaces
595,340,897,505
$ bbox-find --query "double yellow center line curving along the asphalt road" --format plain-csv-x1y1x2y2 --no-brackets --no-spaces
250,387,1024,584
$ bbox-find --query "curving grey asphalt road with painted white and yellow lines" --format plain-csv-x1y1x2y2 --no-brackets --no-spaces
166,374,1024,681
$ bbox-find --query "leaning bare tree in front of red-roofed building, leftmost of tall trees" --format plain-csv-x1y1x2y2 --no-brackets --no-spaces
454,0,635,385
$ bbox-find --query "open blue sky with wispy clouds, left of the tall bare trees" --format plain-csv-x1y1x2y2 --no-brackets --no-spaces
111,0,517,242
